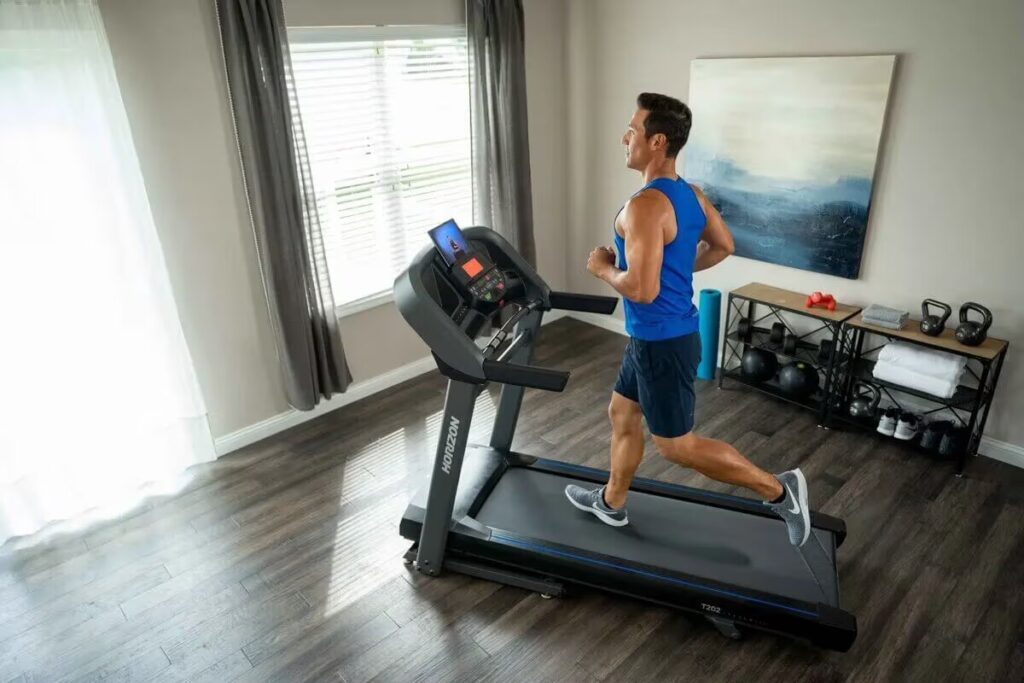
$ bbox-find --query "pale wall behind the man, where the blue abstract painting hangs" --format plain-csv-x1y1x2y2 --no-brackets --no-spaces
566,0,1024,444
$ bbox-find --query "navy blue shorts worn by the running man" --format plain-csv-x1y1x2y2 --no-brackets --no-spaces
615,332,700,438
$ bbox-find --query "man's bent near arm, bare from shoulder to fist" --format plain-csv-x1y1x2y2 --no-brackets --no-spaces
591,193,671,303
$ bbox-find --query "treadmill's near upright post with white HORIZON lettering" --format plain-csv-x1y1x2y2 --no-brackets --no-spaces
416,380,482,577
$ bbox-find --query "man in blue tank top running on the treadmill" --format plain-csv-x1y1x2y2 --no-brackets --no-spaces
565,93,811,547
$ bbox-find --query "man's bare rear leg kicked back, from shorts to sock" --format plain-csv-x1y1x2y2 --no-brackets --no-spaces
654,432,782,501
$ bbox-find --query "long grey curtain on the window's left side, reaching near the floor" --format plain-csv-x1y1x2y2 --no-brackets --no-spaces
216,0,352,411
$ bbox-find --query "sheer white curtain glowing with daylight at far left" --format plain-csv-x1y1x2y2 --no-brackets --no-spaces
0,0,214,544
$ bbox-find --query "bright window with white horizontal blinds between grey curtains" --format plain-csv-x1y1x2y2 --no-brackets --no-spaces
289,27,473,310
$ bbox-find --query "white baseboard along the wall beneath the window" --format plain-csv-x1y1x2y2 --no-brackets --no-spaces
214,310,566,458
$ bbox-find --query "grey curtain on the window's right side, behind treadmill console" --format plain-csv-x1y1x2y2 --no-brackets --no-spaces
466,0,537,265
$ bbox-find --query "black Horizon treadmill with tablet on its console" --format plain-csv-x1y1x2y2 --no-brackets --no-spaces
394,221,857,651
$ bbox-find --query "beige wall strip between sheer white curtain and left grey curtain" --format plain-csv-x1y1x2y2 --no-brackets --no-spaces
99,0,286,436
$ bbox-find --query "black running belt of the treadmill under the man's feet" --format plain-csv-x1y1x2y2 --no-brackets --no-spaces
476,467,838,606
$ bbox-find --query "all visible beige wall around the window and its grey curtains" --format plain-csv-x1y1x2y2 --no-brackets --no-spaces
99,0,566,437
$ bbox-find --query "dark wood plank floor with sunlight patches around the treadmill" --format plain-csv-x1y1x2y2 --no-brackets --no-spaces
0,319,1024,683
